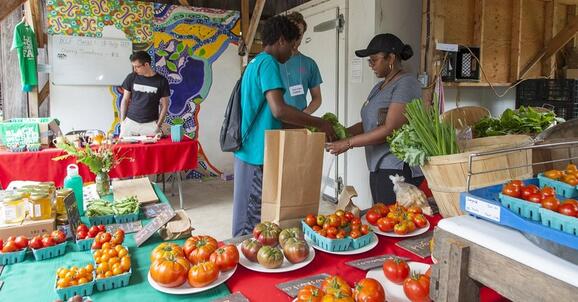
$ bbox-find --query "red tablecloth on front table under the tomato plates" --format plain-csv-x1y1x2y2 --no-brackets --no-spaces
227,215,507,302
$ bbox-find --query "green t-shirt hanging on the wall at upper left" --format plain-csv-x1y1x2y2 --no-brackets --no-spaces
12,21,38,92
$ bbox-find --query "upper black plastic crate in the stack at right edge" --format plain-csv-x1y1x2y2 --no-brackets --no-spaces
516,79,578,105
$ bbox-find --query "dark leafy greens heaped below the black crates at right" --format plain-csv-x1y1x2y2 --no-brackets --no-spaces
473,106,560,137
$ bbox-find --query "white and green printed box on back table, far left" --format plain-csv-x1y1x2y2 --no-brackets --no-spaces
0,117,62,147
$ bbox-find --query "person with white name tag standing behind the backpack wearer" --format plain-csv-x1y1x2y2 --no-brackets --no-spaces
279,12,323,114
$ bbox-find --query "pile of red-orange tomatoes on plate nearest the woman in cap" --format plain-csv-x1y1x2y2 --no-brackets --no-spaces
365,203,428,235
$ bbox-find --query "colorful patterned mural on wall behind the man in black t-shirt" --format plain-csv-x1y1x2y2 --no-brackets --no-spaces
47,0,240,178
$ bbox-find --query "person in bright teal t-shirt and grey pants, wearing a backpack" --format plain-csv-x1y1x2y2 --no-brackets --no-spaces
233,16,335,236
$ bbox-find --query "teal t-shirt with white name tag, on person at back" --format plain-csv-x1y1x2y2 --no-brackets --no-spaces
279,53,323,110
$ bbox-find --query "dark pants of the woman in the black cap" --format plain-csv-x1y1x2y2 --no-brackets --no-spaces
369,164,424,204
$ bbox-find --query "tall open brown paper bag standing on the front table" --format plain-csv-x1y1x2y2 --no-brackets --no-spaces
261,129,325,228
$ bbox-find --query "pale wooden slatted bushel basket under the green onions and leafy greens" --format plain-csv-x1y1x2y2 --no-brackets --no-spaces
421,135,532,217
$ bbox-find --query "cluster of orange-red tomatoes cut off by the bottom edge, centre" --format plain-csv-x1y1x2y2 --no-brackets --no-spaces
297,276,386,302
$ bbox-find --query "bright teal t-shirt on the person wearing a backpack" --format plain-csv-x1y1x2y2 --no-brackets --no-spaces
235,52,285,165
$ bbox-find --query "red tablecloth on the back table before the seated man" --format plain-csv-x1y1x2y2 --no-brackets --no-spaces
0,137,198,188
